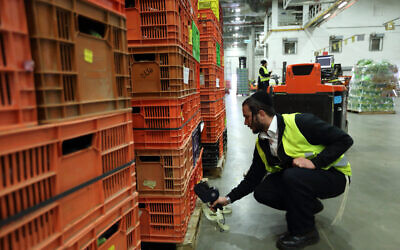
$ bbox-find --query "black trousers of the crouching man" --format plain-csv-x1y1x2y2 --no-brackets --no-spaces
254,167,346,235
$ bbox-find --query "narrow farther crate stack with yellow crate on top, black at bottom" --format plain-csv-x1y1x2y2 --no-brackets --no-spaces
199,0,226,168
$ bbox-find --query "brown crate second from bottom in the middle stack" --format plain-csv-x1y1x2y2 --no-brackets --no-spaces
135,137,193,195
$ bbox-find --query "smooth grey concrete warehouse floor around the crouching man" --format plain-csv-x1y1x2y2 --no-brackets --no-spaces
197,95,400,250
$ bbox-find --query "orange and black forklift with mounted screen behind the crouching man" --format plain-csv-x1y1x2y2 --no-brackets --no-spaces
268,55,348,132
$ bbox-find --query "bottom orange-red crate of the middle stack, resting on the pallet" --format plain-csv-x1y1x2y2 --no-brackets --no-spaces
139,188,190,243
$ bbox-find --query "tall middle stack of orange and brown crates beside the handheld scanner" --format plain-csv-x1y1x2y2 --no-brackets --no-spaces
125,0,202,243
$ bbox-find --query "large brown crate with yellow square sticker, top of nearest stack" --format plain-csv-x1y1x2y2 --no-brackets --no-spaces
26,0,130,123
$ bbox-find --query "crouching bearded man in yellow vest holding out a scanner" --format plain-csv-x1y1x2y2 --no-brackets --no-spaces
213,91,353,249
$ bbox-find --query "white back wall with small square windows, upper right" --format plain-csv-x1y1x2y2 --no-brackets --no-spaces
266,0,400,75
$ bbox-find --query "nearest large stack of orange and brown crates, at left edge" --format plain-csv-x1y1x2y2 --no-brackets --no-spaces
0,0,140,249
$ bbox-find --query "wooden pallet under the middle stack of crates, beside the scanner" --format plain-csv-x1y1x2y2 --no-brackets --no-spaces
142,199,203,250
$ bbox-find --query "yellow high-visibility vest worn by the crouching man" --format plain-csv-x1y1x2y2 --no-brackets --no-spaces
256,114,351,176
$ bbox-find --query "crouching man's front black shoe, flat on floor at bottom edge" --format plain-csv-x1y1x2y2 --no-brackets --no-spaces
276,229,319,250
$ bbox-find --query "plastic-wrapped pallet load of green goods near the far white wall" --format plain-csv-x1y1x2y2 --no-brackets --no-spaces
348,59,398,113
